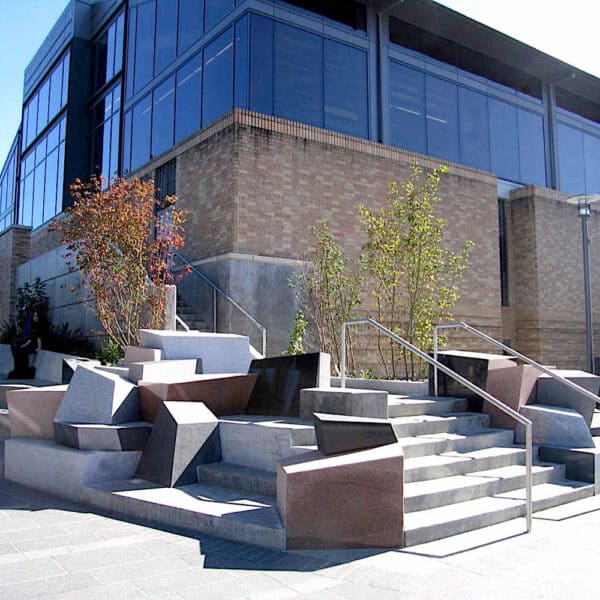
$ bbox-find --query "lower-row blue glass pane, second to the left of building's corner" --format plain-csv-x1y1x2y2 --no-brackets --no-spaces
175,55,202,144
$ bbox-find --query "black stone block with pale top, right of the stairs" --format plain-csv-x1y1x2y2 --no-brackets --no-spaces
429,350,517,412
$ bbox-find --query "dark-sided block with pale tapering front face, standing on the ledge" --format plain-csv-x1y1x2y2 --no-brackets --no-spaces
137,402,221,487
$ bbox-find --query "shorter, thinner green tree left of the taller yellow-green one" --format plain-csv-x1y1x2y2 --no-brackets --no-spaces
291,219,362,372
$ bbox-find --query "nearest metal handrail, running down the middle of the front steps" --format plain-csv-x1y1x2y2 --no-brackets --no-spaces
340,317,533,532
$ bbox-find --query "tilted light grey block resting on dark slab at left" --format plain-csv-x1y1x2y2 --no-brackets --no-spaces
55,365,139,425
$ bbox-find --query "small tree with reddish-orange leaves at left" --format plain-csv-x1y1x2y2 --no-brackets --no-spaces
52,177,185,348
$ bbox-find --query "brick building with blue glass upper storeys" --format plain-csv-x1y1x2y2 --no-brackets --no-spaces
0,0,600,367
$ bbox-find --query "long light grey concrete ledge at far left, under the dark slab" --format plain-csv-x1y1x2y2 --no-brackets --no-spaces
4,438,141,502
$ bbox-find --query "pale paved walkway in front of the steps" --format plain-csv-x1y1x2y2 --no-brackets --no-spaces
0,479,600,600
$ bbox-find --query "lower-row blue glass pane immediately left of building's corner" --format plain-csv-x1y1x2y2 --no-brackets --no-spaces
202,28,233,126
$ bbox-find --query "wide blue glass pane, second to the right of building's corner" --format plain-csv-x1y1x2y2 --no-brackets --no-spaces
275,23,323,127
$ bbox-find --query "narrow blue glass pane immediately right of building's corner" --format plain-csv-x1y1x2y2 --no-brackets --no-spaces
250,15,274,115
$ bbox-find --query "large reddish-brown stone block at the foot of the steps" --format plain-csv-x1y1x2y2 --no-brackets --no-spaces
277,444,404,549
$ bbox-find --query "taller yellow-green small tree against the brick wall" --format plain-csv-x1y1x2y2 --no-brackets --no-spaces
359,166,474,379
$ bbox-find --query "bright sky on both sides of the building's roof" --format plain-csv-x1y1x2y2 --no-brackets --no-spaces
0,0,600,166
